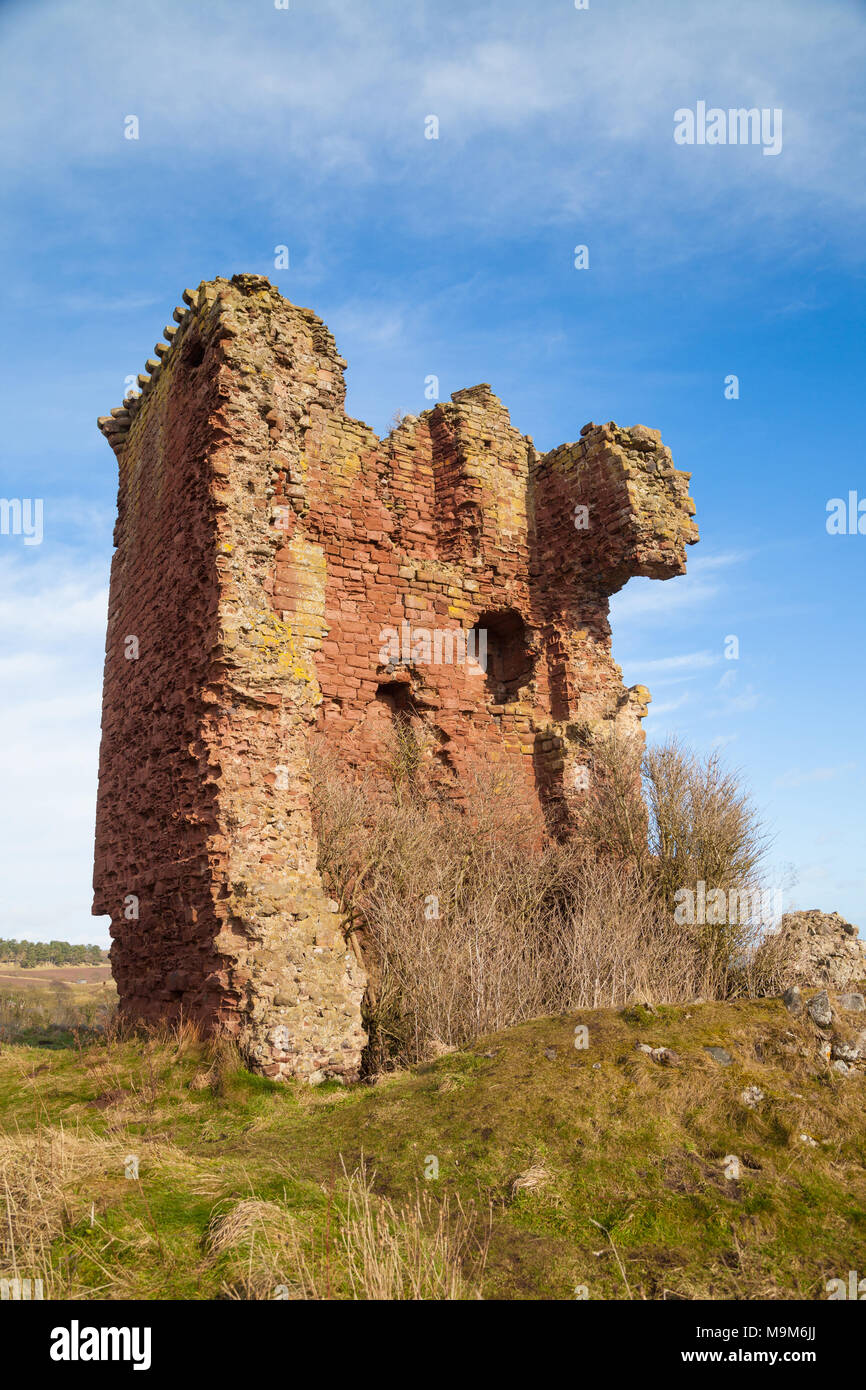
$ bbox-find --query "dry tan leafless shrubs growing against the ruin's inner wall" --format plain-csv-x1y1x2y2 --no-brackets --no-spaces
313,759,708,1066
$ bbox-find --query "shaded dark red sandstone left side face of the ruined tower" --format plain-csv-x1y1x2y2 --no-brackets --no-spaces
93,325,226,1016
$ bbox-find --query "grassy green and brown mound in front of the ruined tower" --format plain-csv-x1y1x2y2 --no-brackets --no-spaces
0,999,866,1300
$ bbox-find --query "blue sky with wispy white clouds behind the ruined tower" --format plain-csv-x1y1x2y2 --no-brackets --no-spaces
0,0,866,944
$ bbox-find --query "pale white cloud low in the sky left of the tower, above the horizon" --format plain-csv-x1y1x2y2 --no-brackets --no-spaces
0,549,107,944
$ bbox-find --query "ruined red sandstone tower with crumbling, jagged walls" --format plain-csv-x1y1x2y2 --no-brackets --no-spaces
93,275,698,1080
